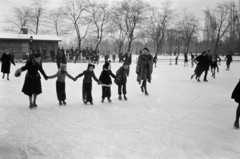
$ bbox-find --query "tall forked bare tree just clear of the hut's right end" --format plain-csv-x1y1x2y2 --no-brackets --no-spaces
64,0,91,49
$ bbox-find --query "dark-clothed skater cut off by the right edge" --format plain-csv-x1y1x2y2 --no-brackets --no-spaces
232,80,240,129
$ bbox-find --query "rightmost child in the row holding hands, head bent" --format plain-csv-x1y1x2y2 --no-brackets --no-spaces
115,62,129,100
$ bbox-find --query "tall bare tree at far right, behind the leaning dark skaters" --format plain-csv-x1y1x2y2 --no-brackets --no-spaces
204,2,237,54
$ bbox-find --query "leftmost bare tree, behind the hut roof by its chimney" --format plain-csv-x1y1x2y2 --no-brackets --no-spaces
2,7,30,34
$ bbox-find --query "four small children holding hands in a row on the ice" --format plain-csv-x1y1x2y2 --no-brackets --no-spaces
48,61,129,105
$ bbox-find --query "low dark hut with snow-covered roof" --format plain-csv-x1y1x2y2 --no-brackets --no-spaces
0,34,62,59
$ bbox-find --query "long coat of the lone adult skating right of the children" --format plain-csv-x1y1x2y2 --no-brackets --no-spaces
136,54,153,84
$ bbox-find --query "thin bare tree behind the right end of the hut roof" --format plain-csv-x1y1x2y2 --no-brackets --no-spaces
49,7,71,36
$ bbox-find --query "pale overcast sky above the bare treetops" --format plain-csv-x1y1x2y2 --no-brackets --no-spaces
0,0,240,39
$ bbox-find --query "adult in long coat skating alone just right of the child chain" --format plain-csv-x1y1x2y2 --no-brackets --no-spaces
136,48,153,95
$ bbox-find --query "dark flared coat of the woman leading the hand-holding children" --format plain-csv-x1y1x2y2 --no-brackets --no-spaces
21,59,48,96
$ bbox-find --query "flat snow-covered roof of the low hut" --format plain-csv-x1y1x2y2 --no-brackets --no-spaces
0,34,62,41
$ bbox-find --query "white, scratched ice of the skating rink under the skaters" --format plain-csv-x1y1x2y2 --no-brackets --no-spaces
0,62,240,159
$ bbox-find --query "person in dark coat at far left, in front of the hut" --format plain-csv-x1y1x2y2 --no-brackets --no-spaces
0,49,15,80
